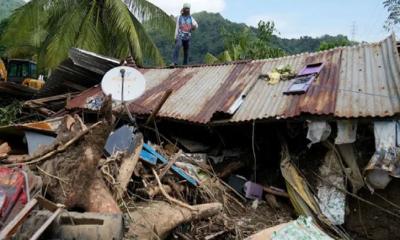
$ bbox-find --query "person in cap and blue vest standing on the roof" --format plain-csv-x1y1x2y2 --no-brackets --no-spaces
173,3,199,66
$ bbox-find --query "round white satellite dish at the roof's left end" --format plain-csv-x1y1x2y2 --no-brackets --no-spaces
101,66,146,102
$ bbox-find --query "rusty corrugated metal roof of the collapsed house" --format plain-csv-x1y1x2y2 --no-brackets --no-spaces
69,35,400,123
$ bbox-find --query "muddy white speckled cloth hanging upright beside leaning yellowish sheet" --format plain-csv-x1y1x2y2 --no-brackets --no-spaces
317,150,346,225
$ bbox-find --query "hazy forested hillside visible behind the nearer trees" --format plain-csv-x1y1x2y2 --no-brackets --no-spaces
149,12,347,63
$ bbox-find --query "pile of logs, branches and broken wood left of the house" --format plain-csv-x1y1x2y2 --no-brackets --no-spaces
0,99,292,239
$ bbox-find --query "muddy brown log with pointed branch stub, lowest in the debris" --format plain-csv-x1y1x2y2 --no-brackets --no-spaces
127,202,222,240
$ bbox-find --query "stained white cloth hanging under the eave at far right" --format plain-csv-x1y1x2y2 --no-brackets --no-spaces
364,121,400,191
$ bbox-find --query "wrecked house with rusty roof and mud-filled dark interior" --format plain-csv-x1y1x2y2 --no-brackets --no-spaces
0,35,400,239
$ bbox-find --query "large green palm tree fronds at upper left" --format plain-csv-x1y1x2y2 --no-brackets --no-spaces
1,0,174,69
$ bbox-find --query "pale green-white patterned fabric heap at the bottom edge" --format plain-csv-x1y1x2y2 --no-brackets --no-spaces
272,216,333,240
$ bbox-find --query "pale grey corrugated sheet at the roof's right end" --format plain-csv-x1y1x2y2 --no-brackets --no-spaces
335,36,400,118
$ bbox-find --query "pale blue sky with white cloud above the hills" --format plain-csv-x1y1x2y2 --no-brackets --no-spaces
24,0,390,42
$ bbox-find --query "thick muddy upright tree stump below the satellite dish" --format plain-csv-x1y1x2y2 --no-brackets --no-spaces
34,96,120,213
